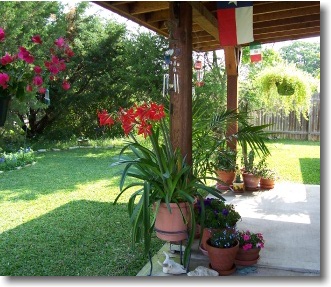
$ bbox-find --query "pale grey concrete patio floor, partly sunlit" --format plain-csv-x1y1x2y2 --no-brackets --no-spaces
137,183,321,276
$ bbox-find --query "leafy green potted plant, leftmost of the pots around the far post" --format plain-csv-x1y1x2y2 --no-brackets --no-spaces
212,148,237,190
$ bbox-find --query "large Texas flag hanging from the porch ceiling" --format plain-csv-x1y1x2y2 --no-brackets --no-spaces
217,1,254,46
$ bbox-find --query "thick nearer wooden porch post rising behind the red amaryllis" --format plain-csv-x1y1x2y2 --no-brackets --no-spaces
169,1,192,164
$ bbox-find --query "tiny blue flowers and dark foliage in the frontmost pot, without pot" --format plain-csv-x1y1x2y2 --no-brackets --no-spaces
207,227,238,248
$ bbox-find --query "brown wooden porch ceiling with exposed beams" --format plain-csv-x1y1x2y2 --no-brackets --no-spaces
93,1,320,51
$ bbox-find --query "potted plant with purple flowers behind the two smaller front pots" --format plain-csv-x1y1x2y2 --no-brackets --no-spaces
194,198,241,255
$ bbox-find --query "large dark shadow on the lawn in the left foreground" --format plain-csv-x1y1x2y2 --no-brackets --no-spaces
0,200,163,276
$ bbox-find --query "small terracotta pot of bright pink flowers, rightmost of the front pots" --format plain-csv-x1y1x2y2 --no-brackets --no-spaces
236,230,265,265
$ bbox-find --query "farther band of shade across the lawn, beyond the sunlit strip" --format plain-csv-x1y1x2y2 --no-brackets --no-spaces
0,149,121,201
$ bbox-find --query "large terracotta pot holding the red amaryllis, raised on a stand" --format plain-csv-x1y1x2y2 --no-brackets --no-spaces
154,202,190,242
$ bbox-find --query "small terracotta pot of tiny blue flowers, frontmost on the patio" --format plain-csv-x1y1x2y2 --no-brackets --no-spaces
206,227,239,275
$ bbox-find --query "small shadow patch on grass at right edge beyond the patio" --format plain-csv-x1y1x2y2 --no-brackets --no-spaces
299,158,321,184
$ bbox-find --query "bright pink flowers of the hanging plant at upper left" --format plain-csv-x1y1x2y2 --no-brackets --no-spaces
0,27,74,98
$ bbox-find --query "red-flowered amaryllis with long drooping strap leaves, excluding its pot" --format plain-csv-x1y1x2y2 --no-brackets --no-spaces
98,102,222,262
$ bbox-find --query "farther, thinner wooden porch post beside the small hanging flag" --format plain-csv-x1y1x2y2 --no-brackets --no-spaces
224,47,241,150
